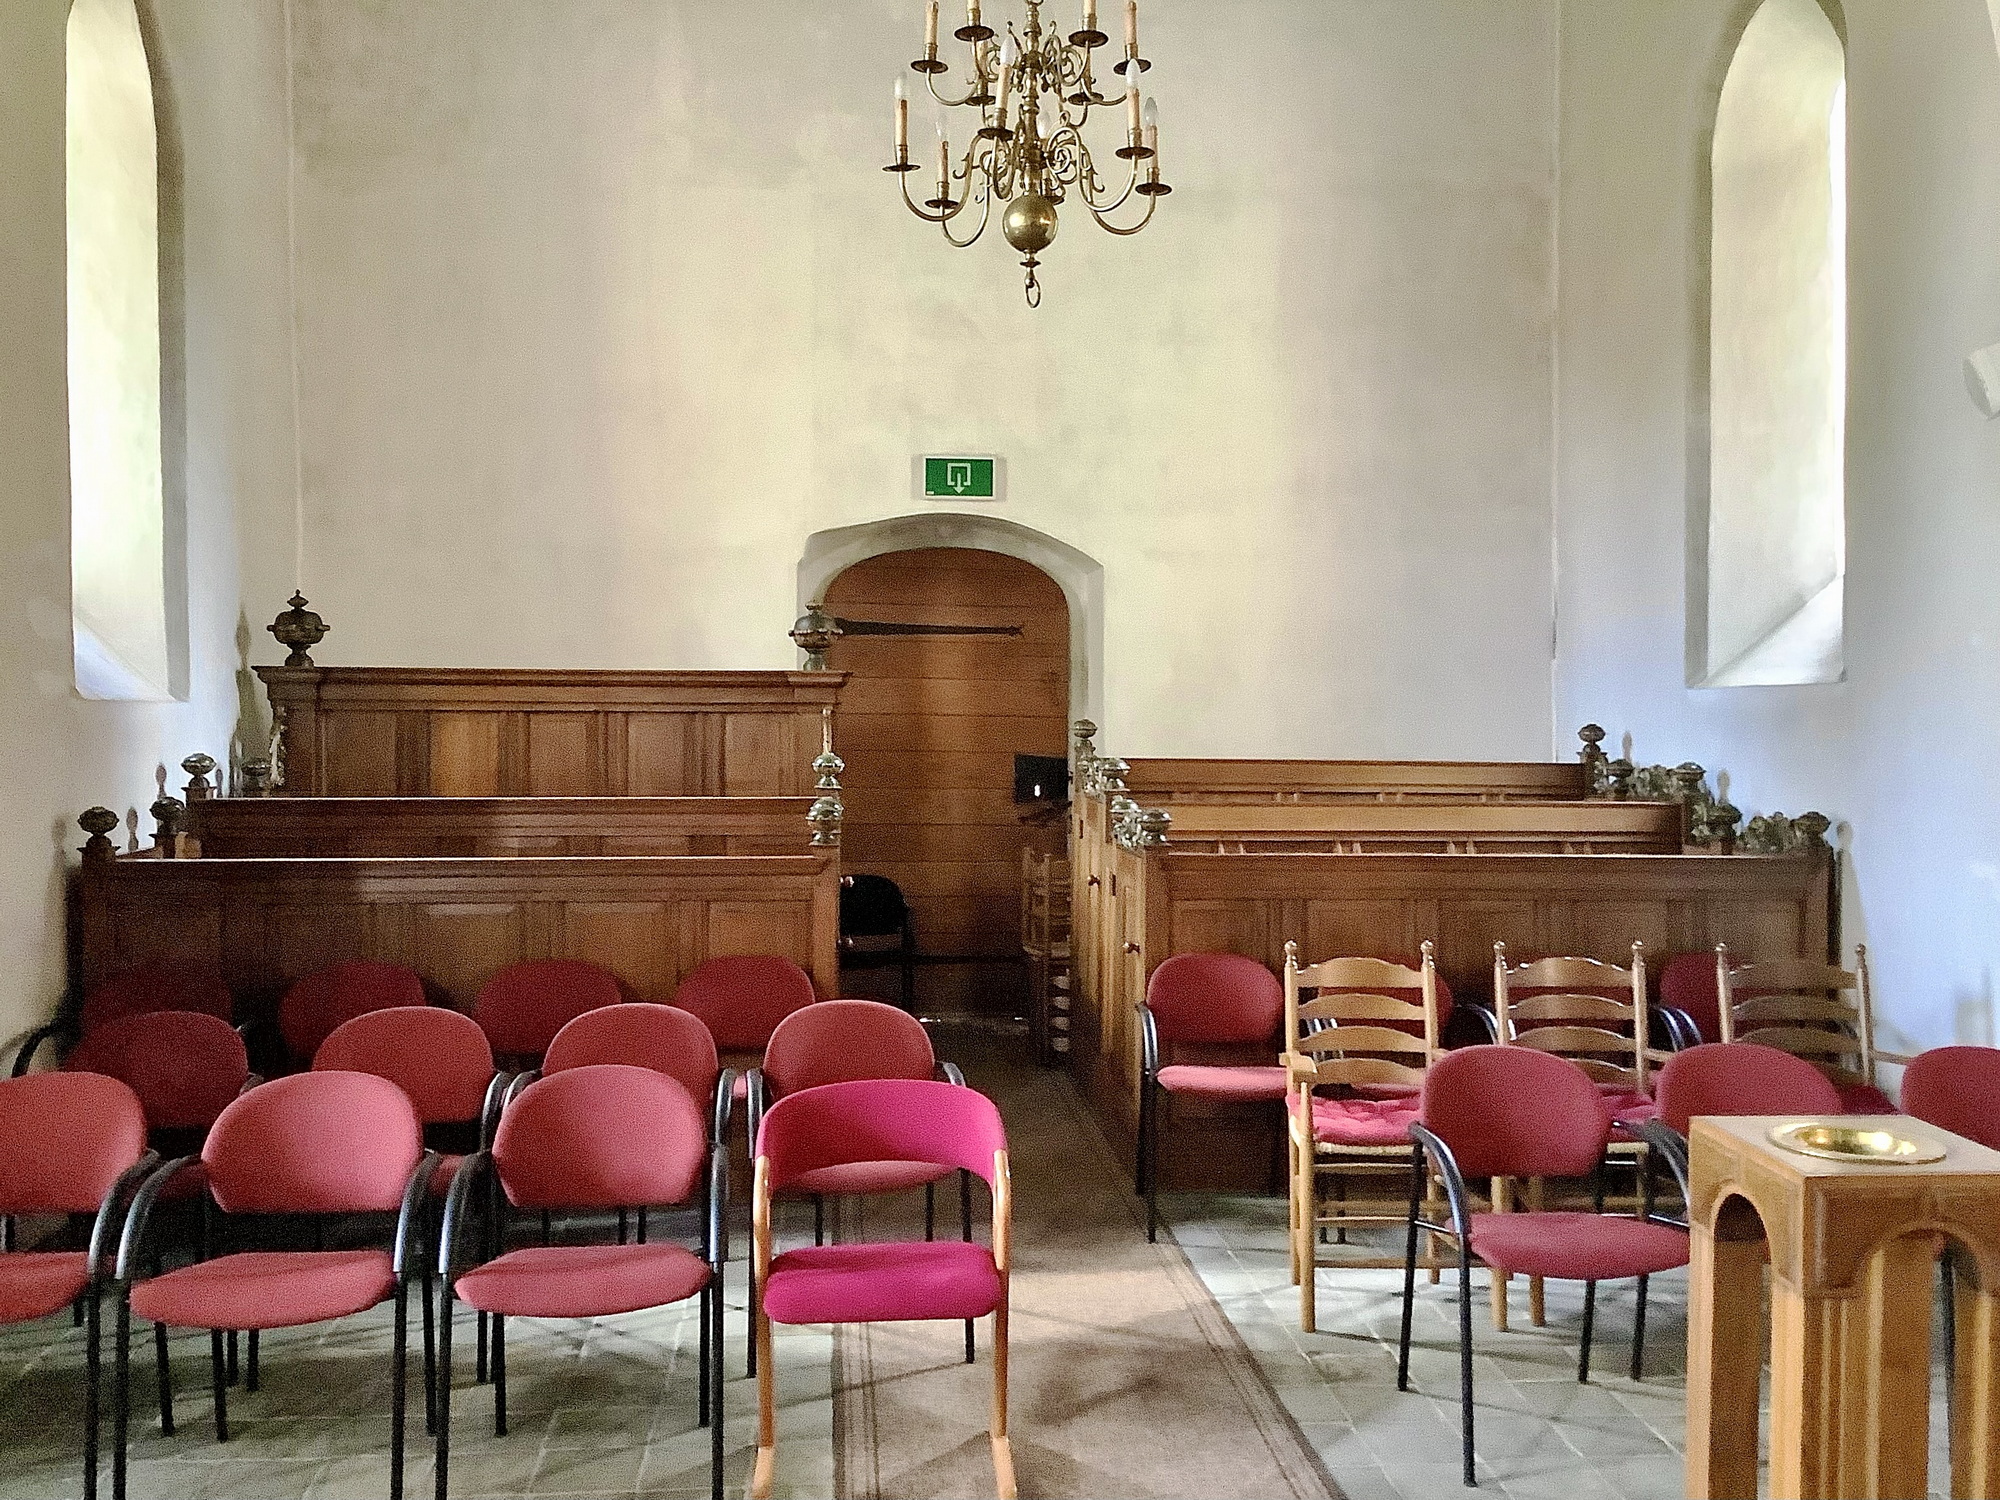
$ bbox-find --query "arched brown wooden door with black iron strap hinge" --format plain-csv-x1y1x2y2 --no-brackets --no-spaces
826,548,1070,1014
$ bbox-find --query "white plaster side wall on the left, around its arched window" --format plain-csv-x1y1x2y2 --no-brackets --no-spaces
0,0,290,1056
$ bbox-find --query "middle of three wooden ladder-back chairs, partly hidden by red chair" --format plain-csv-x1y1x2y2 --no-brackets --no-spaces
1492,942,1664,1330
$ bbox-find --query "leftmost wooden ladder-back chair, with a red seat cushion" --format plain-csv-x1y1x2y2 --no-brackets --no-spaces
1284,942,1438,1332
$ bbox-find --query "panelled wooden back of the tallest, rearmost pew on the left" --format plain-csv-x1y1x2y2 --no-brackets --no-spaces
256,666,842,796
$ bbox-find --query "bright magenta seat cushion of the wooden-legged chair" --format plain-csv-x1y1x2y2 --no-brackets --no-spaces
764,1240,1006,1322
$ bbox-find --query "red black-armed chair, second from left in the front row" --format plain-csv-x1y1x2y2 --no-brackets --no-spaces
112,1072,438,1500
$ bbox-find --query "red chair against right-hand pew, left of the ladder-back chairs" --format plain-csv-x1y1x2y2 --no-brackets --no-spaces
1134,954,1286,1240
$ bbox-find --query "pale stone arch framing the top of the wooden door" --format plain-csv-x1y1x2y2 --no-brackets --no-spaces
798,510,1104,722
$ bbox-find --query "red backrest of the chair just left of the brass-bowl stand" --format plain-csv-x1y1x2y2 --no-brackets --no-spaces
1420,1046,1612,1178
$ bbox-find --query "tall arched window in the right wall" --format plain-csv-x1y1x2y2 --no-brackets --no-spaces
1694,0,1848,686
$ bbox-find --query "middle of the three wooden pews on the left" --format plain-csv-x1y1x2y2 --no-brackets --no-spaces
182,796,812,858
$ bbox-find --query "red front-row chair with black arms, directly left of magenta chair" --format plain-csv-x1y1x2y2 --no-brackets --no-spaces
436,1062,728,1500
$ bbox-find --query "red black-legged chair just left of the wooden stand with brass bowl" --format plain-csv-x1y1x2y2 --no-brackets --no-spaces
1396,1046,1688,1484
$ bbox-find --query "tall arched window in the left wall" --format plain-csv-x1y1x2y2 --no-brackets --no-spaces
66,0,172,698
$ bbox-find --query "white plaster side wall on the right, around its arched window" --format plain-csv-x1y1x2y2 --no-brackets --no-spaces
1556,0,2000,1048
